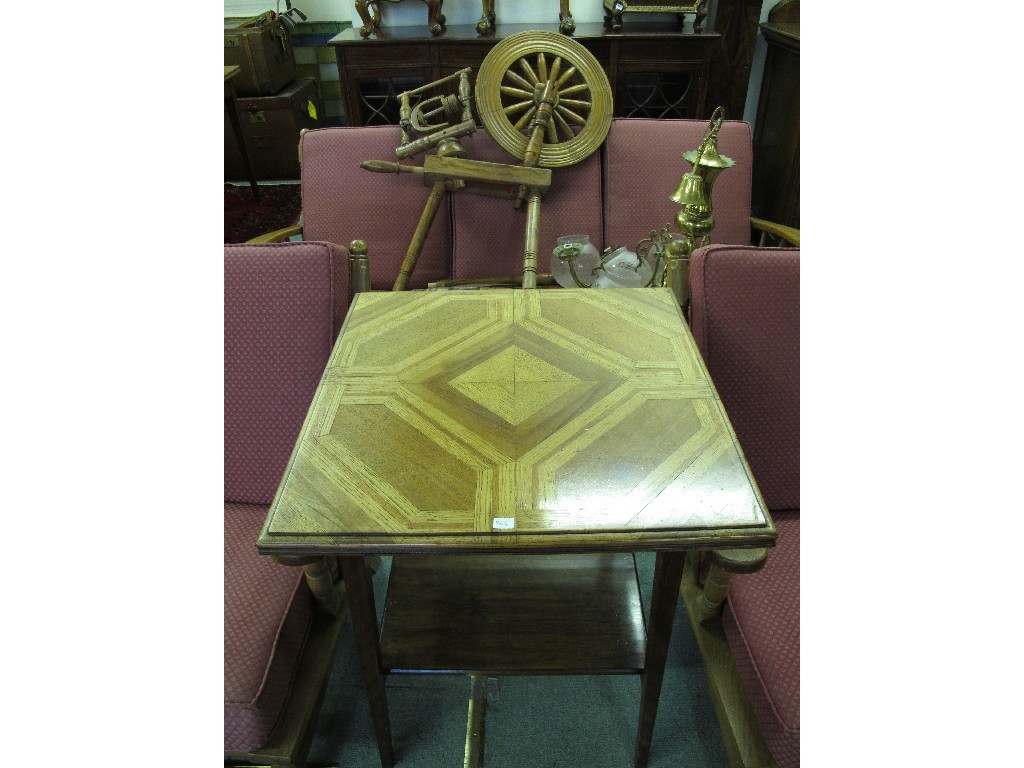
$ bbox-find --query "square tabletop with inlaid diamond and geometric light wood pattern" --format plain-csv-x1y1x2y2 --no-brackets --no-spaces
265,289,766,541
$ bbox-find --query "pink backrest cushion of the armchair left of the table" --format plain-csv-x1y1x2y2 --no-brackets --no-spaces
224,242,348,504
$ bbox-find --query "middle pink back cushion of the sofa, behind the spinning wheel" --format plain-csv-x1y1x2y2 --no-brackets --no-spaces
452,130,603,278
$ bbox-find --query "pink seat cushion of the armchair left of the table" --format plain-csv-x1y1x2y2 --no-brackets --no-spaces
224,503,312,753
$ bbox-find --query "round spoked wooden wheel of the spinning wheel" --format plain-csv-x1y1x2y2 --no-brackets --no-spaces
476,30,611,168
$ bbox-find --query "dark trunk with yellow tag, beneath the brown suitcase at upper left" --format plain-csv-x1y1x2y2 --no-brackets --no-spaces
224,78,323,181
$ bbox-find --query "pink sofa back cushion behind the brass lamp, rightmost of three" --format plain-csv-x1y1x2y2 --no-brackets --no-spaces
592,118,754,248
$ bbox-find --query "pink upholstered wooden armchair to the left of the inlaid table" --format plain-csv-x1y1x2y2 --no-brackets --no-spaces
224,242,347,768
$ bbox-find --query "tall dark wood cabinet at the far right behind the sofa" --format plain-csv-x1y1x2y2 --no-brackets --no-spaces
751,0,800,229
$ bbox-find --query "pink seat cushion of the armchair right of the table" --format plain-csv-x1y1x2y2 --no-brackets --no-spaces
722,511,800,768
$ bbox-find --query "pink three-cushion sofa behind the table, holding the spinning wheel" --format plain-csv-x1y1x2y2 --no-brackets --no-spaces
260,118,753,305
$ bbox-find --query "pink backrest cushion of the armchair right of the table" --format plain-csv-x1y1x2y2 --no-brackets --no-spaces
690,245,800,510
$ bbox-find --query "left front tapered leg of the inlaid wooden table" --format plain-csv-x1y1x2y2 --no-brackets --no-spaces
340,556,393,768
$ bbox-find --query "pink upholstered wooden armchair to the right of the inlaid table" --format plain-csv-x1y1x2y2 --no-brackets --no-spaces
682,245,800,768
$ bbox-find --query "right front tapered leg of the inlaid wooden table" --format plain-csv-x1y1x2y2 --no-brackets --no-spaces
635,552,686,768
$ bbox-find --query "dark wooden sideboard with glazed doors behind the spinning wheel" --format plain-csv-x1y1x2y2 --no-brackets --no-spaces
329,19,721,125
